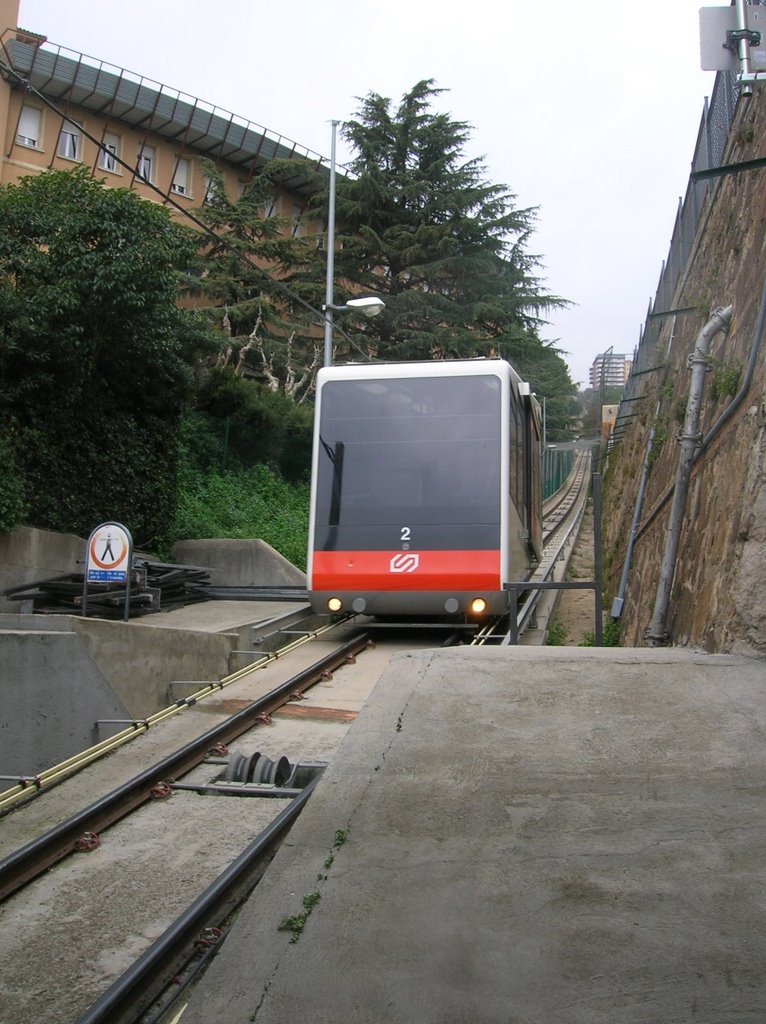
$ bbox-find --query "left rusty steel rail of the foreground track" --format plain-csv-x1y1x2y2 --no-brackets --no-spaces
0,633,369,902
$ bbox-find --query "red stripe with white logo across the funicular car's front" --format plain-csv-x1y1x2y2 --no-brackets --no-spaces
310,551,500,591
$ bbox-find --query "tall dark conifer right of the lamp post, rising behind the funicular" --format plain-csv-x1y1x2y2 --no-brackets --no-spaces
323,80,564,360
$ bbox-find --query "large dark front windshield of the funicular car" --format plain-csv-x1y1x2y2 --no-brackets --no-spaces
316,374,501,530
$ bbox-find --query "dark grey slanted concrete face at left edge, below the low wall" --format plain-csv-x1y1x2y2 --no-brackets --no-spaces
0,615,131,774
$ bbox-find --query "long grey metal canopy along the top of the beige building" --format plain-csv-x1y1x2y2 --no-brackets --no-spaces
4,39,329,194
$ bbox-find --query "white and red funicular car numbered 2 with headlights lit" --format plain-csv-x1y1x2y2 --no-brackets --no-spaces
308,359,543,622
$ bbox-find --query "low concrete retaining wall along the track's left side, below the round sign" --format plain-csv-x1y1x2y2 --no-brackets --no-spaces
0,614,244,775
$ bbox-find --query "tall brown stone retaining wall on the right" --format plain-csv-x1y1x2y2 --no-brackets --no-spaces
603,86,766,652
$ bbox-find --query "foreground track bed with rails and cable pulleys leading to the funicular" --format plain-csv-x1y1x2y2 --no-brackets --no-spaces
0,624,432,1024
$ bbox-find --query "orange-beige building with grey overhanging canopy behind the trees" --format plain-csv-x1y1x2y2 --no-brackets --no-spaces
0,0,323,234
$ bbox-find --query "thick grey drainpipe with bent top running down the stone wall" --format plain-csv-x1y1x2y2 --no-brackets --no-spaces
646,306,733,647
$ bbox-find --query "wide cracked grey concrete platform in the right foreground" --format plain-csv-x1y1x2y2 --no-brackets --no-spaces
181,647,766,1024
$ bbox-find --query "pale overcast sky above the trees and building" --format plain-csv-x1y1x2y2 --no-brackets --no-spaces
18,0,716,386
